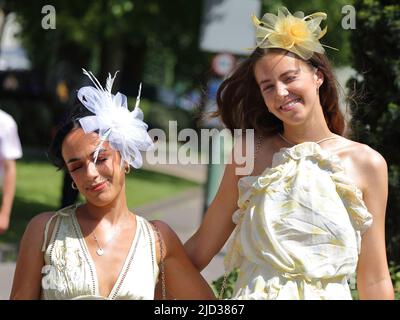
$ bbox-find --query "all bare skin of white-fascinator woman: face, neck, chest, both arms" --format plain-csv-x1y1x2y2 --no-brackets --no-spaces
10,128,215,299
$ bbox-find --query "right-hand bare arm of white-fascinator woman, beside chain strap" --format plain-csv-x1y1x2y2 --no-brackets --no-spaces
153,221,215,300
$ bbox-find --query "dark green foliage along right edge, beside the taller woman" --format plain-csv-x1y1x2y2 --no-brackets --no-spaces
349,0,400,264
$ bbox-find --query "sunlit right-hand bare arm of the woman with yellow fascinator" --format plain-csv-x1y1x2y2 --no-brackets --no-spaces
357,148,394,299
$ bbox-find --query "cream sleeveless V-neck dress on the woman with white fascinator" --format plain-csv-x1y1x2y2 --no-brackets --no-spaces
41,205,159,300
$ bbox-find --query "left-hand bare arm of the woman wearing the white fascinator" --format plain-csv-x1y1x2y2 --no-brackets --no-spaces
10,212,54,300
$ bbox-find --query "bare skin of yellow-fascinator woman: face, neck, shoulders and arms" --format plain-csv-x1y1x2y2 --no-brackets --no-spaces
185,51,394,299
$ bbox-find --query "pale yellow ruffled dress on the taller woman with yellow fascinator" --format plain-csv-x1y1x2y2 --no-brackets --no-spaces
225,142,372,299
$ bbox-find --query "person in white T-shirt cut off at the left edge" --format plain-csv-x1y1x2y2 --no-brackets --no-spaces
0,110,22,234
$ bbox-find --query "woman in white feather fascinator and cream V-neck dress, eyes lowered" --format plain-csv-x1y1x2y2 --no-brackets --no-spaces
10,70,214,300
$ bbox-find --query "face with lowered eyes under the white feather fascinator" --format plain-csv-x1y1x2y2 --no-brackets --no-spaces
62,128,125,206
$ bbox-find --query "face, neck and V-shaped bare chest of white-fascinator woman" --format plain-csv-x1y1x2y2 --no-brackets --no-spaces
62,129,136,296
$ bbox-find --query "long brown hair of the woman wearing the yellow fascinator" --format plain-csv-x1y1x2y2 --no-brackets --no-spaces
213,48,346,136
